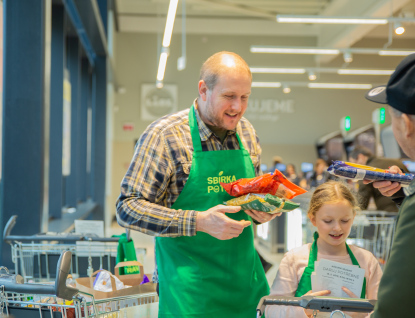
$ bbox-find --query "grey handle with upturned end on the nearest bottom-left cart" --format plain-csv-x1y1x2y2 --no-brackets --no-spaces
0,251,78,300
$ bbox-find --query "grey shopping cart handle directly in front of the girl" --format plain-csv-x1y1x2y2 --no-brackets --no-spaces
257,296,376,318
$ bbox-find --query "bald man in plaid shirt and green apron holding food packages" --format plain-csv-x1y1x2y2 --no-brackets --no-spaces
116,52,276,318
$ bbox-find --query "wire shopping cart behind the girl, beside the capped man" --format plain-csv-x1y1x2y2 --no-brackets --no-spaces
347,211,397,266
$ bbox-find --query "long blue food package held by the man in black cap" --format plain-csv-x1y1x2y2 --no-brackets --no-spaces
327,161,415,186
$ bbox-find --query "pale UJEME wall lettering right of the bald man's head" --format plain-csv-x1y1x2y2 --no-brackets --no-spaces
245,98,295,122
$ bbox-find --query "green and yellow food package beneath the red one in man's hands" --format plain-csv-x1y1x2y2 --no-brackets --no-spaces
224,193,300,214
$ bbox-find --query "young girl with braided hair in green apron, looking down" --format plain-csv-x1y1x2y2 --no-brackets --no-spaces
265,181,382,318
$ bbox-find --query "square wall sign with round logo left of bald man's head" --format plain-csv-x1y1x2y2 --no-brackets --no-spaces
141,84,177,121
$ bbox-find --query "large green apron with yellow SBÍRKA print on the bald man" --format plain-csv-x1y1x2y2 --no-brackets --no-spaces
156,106,269,318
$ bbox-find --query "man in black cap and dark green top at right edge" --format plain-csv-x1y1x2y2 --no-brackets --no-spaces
366,54,415,318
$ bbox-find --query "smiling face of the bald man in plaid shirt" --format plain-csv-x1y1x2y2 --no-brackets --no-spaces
202,71,251,130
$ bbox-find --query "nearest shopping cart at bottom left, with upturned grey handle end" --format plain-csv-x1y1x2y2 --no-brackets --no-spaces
0,251,158,318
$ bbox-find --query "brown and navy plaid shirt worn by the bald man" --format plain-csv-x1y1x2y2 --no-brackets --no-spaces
116,101,261,237
